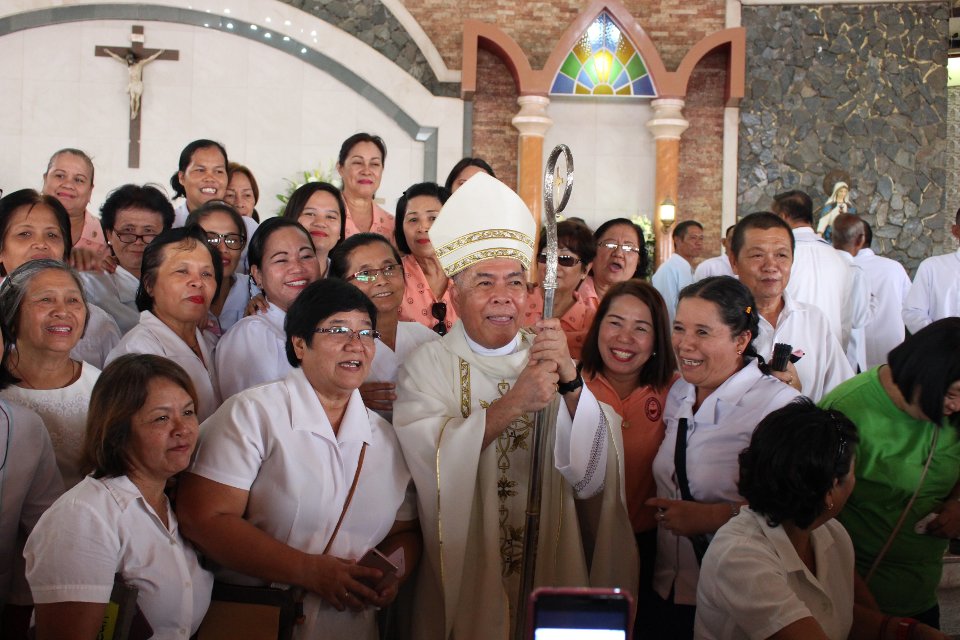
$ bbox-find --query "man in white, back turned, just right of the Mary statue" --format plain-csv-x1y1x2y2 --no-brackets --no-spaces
833,213,910,369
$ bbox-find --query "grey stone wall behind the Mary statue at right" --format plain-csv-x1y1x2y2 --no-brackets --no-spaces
738,2,956,270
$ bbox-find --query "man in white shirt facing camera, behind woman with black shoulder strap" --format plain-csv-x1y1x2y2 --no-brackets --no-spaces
730,212,853,402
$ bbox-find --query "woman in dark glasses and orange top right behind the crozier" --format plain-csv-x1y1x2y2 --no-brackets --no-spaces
523,220,597,360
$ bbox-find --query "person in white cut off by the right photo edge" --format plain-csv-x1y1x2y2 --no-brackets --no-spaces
903,209,960,333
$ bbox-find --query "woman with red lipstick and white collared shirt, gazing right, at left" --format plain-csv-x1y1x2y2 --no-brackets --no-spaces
106,225,223,420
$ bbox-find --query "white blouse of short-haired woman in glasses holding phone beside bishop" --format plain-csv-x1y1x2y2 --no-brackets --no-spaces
191,368,417,640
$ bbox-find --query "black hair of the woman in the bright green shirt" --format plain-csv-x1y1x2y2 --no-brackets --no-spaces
887,316,960,429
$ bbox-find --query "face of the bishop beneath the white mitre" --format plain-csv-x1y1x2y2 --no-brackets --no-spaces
452,258,527,349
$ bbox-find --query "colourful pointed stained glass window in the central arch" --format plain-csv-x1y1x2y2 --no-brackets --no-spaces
550,11,657,98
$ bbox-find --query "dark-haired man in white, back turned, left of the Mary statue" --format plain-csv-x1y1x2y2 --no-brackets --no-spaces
773,191,868,345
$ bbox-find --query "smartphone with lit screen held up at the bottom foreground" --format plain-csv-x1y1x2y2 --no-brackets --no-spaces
527,588,633,640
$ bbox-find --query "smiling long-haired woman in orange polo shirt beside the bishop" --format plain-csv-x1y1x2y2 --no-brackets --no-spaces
581,279,677,629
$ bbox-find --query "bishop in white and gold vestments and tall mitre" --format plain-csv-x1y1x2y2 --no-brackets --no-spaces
394,174,638,640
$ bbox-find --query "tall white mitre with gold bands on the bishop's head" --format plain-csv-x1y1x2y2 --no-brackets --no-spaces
428,172,536,277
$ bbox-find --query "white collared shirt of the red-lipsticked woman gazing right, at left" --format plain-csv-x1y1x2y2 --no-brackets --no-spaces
107,311,220,420
